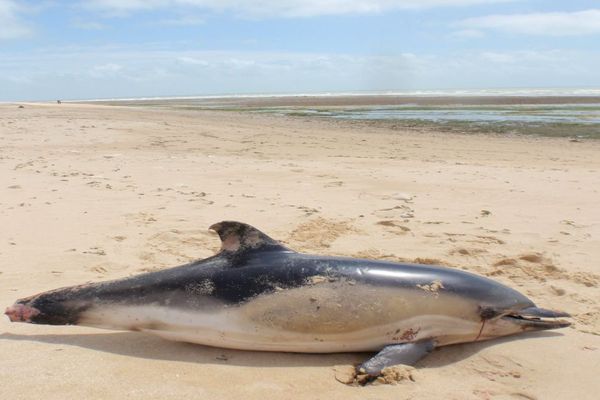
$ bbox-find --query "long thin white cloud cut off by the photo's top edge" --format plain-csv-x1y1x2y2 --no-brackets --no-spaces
85,0,519,18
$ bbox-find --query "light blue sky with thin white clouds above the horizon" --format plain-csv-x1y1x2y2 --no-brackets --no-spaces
0,0,600,101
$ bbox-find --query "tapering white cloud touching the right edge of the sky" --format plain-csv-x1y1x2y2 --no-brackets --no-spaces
456,9,600,36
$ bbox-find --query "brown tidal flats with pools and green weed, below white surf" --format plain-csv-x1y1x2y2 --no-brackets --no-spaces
70,96,600,140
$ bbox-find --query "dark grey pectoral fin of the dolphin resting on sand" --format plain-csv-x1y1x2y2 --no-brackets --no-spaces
357,339,435,376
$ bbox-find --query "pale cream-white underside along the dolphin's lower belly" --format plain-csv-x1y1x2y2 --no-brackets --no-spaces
81,305,481,353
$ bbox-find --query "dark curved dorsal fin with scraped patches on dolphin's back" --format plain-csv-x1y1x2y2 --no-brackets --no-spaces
209,221,291,254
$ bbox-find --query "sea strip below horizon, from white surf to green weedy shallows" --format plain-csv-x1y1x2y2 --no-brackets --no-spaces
78,88,600,139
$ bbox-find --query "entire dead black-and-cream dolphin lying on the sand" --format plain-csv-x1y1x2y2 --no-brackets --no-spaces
6,221,569,376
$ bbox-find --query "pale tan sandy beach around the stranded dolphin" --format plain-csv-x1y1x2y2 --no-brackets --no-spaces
0,103,600,400
